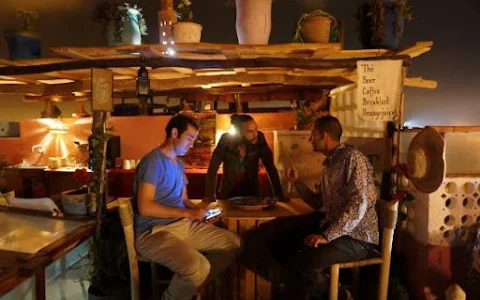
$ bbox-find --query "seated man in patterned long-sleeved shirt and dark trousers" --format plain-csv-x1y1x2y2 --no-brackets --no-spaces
243,116,378,299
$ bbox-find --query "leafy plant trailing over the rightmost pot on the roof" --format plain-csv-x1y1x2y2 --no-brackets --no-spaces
356,0,413,42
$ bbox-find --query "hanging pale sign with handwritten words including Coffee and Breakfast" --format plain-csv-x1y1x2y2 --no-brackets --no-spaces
357,60,403,121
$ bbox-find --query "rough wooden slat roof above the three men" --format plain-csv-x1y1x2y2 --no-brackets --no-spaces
0,42,436,98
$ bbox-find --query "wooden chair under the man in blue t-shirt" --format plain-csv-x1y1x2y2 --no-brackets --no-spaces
118,198,201,300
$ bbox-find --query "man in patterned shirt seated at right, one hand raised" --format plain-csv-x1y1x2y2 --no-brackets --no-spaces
277,116,378,295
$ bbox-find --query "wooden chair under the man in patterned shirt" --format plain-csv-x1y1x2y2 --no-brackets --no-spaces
330,201,398,300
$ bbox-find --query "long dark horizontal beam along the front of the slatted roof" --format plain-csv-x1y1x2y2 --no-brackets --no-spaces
0,55,411,75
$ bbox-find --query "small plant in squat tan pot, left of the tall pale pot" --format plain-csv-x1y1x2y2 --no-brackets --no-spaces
173,0,202,43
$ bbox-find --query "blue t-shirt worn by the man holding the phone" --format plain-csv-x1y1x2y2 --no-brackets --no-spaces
132,148,188,233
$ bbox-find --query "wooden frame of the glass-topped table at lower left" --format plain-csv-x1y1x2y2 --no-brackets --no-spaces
0,207,95,300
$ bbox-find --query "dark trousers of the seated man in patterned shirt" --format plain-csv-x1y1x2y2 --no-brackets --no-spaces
243,213,374,299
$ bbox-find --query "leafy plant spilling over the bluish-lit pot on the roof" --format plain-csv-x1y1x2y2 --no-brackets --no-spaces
93,2,147,41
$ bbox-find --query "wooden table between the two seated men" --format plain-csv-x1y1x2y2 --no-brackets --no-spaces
193,199,313,300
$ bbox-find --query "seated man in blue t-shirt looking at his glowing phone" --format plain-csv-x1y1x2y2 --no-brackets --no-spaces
132,115,241,300
